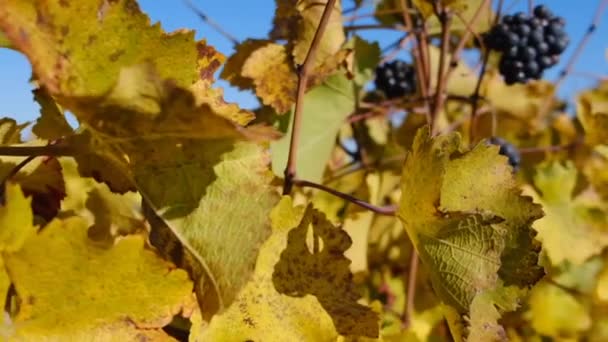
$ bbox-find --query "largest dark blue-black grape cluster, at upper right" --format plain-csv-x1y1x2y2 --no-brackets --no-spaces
485,5,570,85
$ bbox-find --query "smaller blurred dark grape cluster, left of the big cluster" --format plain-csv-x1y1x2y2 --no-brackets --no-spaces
375,60,416,99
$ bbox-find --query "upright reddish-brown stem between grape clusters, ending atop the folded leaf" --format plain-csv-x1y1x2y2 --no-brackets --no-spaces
430,2,452,133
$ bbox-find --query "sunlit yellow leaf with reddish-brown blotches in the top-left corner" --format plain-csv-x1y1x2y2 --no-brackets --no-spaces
0,0,199,96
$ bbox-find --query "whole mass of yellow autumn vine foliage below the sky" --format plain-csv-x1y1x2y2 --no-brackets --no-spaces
0,0,608,341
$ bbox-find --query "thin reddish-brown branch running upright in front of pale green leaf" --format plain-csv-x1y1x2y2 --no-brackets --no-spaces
283,0,336,195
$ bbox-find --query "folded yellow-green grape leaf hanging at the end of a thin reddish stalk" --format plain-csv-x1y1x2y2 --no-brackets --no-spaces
398,128,543,339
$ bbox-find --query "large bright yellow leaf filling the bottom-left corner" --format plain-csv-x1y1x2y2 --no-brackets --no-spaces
2,217,193,341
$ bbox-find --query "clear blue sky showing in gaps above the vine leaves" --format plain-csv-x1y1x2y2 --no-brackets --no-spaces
0,0,608,122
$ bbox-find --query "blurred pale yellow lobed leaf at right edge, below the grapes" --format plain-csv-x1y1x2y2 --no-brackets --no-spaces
530,162,608,265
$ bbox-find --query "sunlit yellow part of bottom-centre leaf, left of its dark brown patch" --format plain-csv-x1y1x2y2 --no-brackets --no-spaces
195,197,338,341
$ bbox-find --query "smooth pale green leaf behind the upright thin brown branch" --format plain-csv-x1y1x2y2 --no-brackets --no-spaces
271,74,355,182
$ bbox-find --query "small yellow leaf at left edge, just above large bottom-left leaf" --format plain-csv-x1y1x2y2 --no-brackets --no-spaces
0,182,36,252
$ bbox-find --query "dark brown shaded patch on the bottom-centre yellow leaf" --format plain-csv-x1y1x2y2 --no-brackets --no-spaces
272,205,379,337
